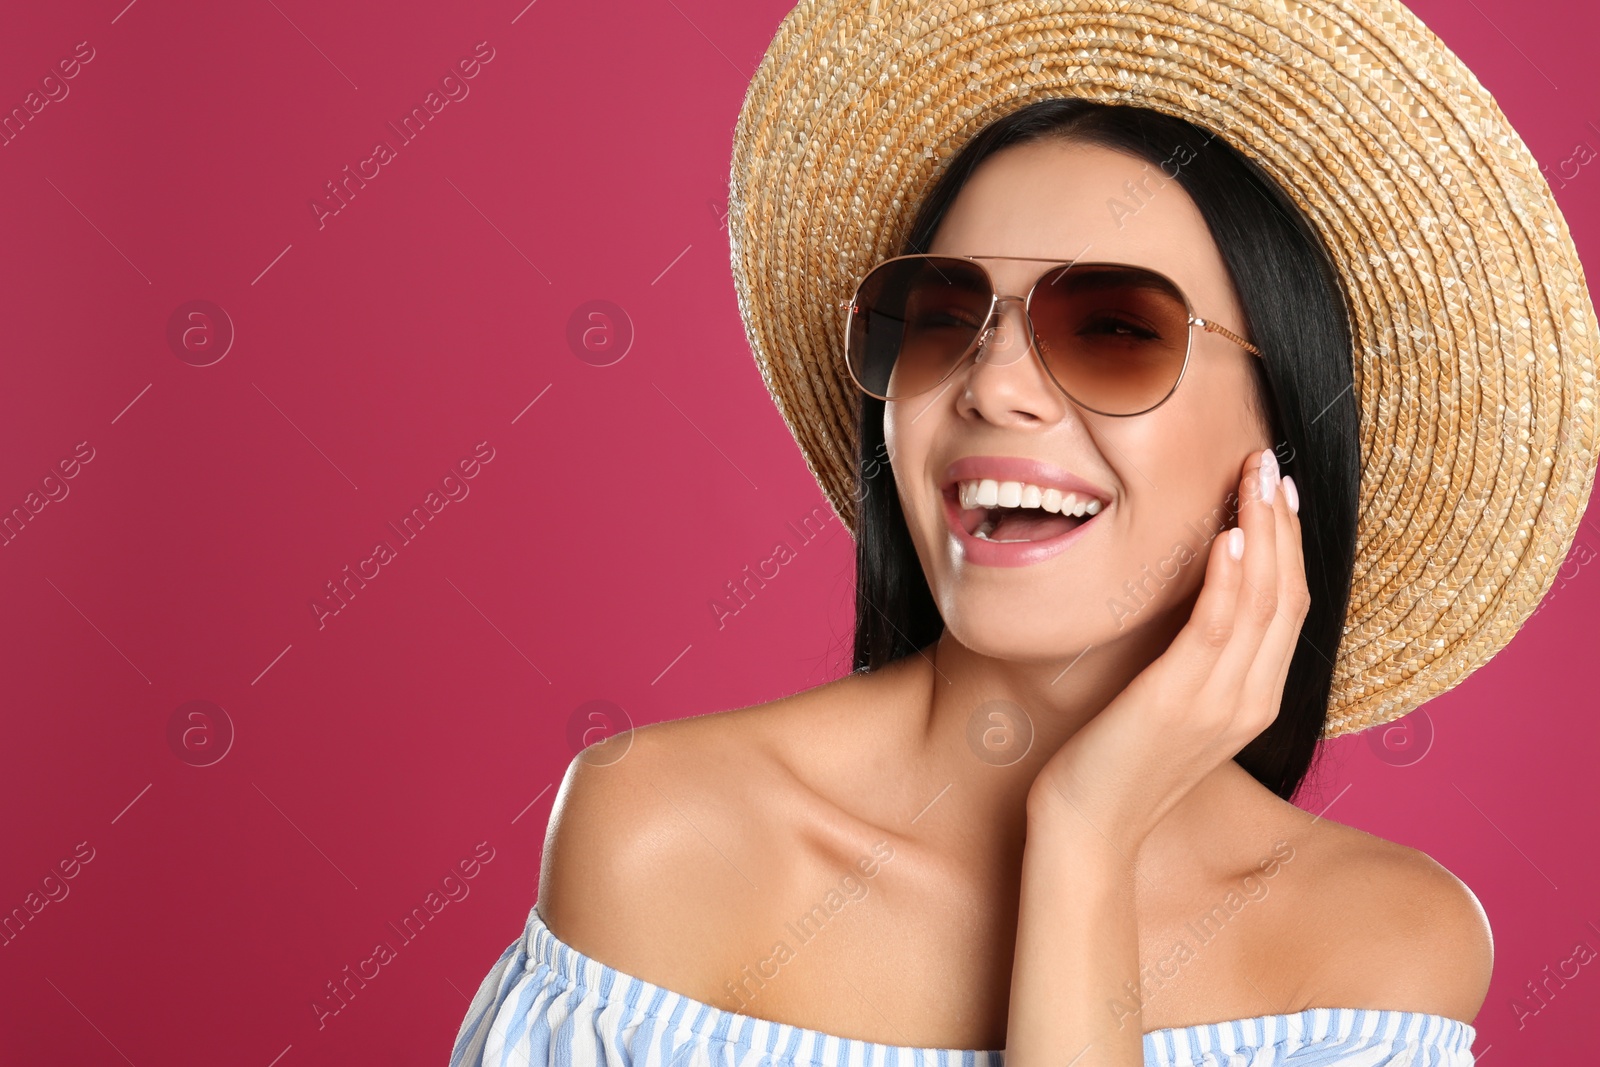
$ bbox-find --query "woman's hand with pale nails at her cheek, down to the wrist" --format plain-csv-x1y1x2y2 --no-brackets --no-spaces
1027,450,1310,861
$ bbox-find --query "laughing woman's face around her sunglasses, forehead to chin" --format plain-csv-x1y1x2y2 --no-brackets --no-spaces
883,142,1272,662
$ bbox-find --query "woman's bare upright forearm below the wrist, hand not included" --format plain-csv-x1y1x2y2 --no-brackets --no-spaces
1006,803,1144,1067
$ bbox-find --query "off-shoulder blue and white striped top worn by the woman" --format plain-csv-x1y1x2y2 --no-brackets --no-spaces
450,907,1477,1067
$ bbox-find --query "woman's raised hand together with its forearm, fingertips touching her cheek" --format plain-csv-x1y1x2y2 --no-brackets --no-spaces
1006,451,1310,1067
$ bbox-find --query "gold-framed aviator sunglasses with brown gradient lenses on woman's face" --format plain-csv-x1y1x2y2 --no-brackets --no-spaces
838,254,1261,416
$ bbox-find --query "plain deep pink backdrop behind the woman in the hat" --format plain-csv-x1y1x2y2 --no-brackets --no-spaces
0,0,1600,1067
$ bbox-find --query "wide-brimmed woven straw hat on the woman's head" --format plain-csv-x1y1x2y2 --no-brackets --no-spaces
728,0,1600,737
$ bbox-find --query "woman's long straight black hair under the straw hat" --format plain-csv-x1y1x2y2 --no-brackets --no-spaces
854,98,1360,800
